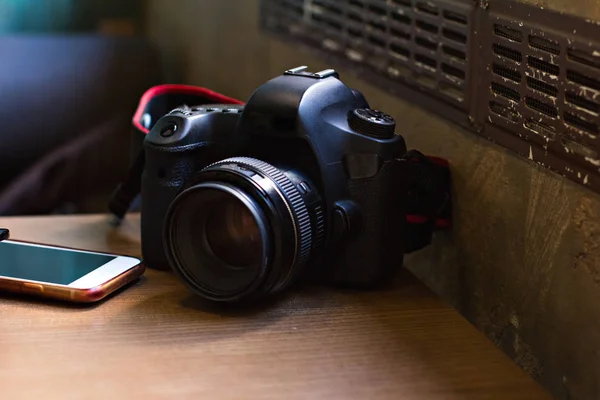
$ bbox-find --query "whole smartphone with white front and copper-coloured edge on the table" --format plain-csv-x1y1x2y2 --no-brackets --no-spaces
0,240,145,303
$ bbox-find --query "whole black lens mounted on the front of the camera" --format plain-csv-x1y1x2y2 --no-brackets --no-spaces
164,157,323,301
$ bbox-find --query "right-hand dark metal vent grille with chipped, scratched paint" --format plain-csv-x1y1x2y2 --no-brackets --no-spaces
480,12,600,185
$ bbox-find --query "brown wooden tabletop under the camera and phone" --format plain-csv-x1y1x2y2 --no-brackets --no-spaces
0,215,548,400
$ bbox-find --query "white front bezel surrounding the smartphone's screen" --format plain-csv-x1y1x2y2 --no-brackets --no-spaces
0,240,141,290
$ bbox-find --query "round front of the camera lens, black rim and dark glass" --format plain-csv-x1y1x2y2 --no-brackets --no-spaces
167,183,270,297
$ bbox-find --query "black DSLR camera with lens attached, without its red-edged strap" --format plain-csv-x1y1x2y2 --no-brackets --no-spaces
141,67,410,301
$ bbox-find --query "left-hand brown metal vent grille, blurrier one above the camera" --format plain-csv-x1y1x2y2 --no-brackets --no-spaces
262,0,473,111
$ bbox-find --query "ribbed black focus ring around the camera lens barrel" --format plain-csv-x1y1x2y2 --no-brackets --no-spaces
205,157,312,264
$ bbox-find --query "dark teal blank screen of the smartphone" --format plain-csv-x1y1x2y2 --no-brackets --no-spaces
0,242,116,285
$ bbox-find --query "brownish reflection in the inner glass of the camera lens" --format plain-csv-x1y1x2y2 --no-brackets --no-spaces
205,197,262,268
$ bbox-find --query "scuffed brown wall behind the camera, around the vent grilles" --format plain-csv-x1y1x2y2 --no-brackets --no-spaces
147,0,600,399
